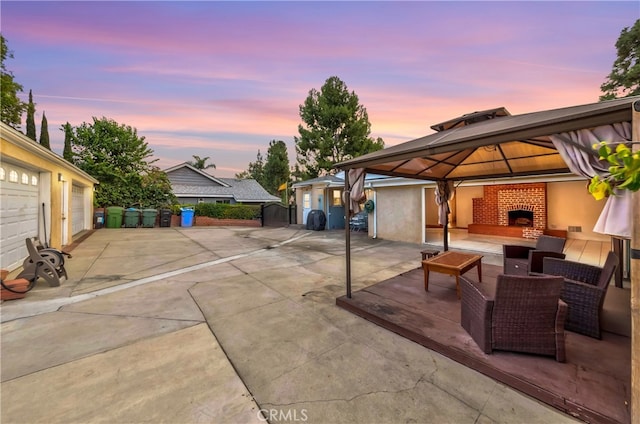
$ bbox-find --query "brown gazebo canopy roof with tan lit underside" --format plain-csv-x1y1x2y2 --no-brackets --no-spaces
335,96,640,180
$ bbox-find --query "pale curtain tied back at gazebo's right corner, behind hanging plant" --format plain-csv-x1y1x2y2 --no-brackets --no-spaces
550,122,632,238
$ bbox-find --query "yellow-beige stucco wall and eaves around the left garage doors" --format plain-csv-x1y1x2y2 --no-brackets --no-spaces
0,125,96,249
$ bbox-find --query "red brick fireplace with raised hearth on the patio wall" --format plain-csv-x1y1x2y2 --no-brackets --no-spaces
468,183,547,238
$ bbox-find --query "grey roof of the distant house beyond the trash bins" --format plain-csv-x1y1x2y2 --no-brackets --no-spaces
164,162,280,203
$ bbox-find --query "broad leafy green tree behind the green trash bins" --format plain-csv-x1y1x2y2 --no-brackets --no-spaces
71,117,172,207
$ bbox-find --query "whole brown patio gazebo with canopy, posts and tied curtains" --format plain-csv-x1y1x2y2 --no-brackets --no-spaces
336,96,640,416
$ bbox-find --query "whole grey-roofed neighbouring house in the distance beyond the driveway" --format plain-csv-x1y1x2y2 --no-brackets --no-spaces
164,162,280,205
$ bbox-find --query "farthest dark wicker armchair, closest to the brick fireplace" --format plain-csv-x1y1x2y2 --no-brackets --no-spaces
502,235,567,275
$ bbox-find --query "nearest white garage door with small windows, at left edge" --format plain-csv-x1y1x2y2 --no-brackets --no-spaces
0,162,40,270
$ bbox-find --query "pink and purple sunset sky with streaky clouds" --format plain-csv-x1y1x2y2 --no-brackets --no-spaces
1,1,640,177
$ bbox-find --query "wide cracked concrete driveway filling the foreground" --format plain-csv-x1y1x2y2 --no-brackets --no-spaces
0,227,575,424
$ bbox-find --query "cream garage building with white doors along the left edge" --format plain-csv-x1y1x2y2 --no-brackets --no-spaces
0,123,98,270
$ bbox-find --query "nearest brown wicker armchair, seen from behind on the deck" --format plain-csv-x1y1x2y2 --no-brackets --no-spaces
460,274,567,362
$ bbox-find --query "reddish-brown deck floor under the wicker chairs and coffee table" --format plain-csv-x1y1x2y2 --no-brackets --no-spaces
336,264,631,424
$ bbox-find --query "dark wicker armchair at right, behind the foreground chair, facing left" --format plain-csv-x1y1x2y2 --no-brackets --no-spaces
542,252,618,339
